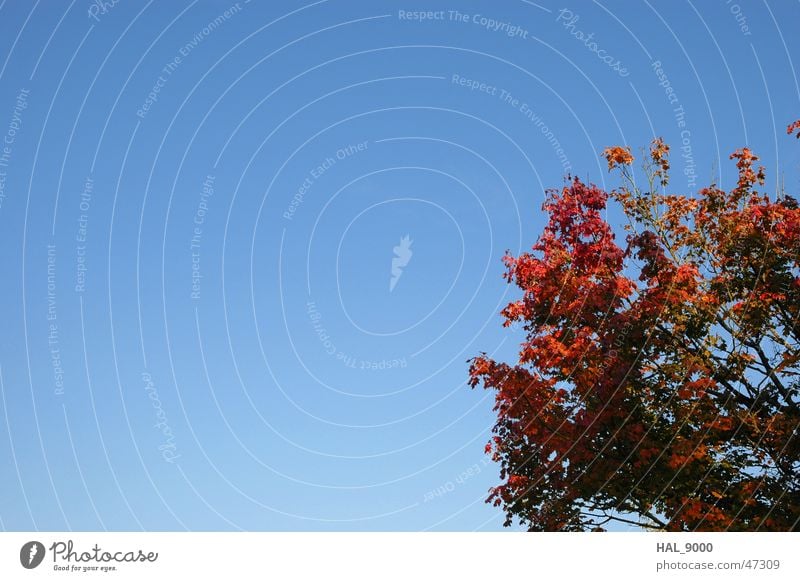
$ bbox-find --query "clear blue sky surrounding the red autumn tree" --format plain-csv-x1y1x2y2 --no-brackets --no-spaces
0,0,800,530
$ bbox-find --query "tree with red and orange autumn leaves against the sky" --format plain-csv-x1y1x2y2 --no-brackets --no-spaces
469,121,800,531
